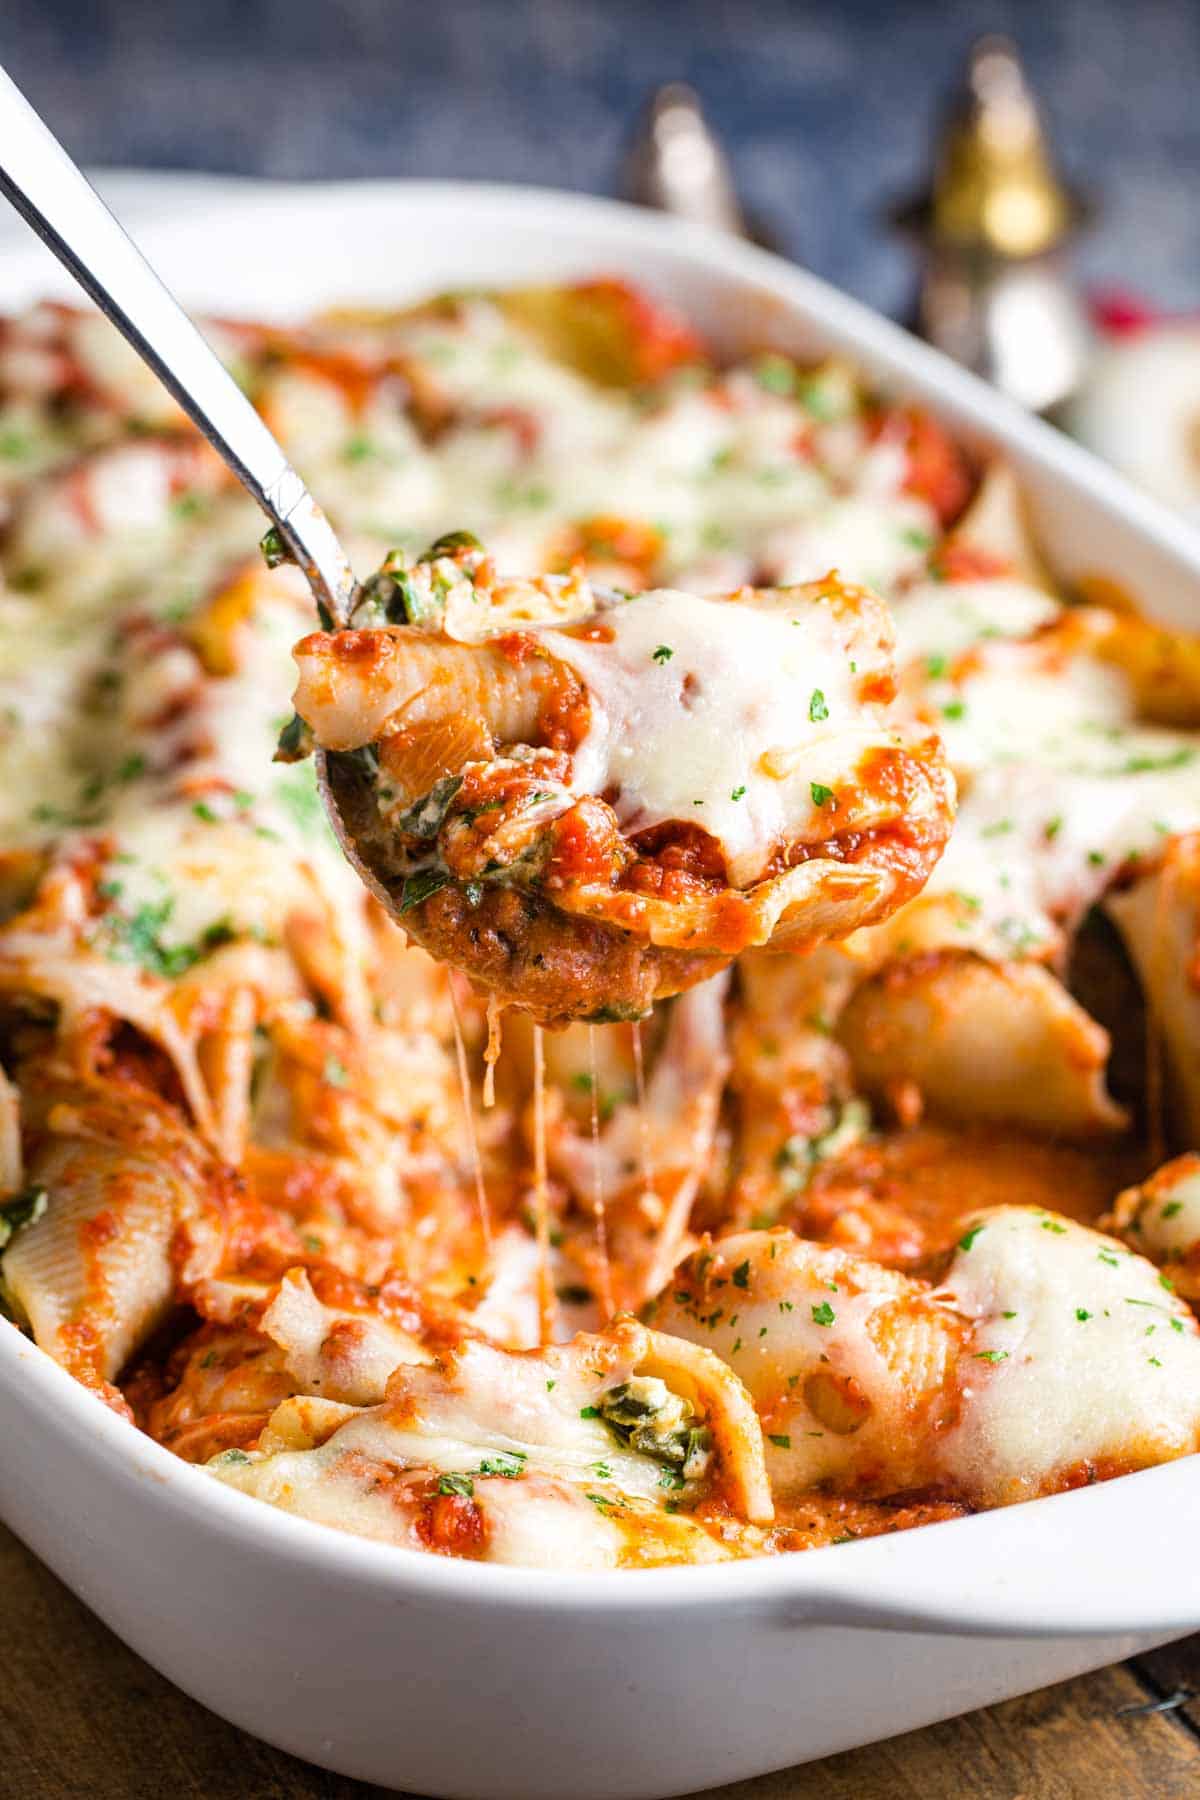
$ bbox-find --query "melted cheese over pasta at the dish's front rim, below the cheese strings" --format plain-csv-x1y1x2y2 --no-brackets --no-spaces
207,1324,752,1568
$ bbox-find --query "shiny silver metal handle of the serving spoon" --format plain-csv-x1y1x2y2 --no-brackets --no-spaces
0,68,354,621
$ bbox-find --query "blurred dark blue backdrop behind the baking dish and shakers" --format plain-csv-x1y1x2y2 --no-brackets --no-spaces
0,0,1200,311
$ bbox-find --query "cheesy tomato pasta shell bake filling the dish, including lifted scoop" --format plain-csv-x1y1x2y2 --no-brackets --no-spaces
0,281,1200,1568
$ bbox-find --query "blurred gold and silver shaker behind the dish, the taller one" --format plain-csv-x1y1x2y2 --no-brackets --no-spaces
892,38,1092,412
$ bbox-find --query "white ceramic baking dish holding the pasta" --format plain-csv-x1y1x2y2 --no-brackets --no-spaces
0,178,1200,1800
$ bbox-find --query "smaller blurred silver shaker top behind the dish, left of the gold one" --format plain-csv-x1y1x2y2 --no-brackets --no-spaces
621,81,780,243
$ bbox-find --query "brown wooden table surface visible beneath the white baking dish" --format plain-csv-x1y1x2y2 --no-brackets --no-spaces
0,1528,1200,1800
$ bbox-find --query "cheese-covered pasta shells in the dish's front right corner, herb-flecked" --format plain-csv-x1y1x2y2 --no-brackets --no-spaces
655,1206,1200,1507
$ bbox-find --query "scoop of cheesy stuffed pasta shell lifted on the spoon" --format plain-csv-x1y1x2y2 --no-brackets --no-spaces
290,540,954,1024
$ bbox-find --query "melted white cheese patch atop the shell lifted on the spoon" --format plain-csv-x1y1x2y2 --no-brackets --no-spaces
542,589,885,886
